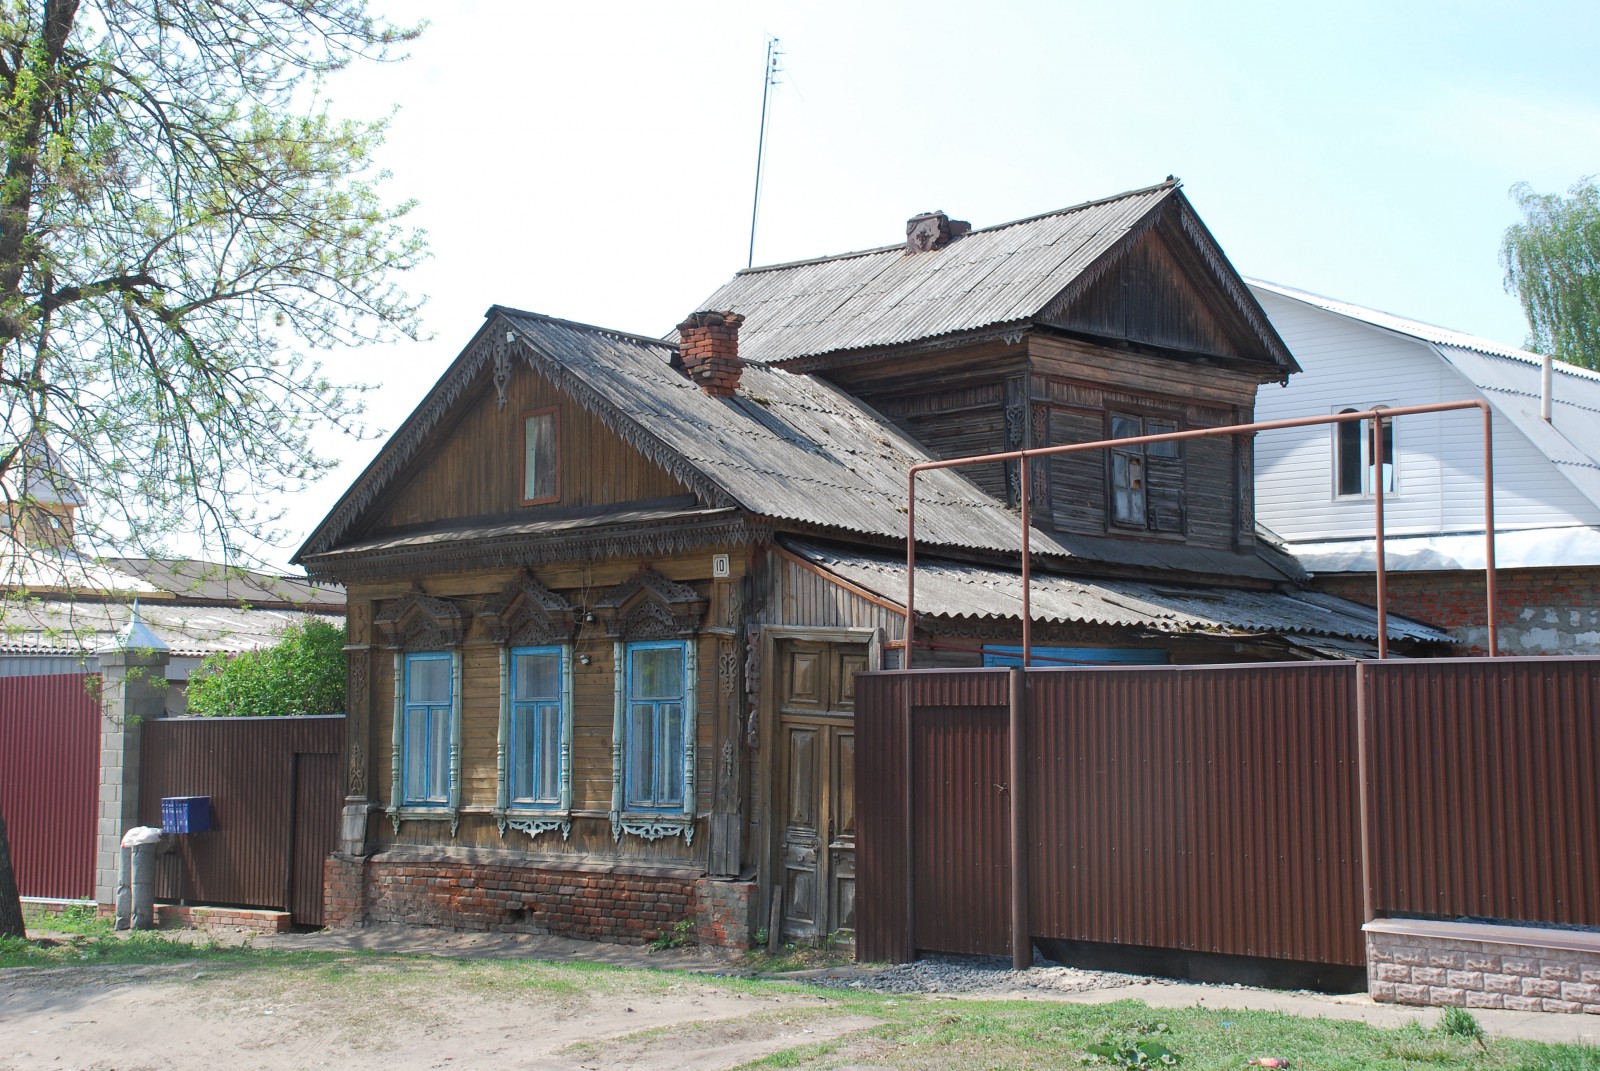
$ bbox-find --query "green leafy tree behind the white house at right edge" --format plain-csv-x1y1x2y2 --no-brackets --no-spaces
1501,176,1600,368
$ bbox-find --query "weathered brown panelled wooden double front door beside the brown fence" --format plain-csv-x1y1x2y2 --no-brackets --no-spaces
773,640,867,943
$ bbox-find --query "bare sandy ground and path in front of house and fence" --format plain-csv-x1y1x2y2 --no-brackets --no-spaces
0,927,1600,1071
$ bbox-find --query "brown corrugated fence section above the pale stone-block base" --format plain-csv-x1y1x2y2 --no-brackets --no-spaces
1363,658,1600,925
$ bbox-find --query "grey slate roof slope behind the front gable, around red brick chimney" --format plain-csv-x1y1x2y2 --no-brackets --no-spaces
496,309,1302,580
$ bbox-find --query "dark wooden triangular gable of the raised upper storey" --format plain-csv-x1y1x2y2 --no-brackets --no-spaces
1038,215,1283,371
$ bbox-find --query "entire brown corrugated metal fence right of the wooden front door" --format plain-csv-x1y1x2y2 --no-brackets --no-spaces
856,658,1600,965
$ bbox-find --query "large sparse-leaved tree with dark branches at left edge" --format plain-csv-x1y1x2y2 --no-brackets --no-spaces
0,0,424,934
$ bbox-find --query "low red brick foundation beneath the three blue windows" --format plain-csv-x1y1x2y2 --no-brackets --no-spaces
323,853,757,948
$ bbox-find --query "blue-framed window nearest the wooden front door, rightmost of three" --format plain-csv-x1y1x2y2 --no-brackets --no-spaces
622,640,688,810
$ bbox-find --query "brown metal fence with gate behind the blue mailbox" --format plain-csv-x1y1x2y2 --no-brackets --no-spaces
139,716,344,925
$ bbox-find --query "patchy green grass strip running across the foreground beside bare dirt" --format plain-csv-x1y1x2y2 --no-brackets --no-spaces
0,919,1600,1071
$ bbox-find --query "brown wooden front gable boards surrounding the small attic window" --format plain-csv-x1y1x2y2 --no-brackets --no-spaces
363,362,690,535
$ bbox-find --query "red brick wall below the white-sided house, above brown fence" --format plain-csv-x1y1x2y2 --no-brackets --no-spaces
1312,567,1600,655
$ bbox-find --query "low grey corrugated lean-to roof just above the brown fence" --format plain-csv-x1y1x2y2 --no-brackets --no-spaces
784,540,1450,644
